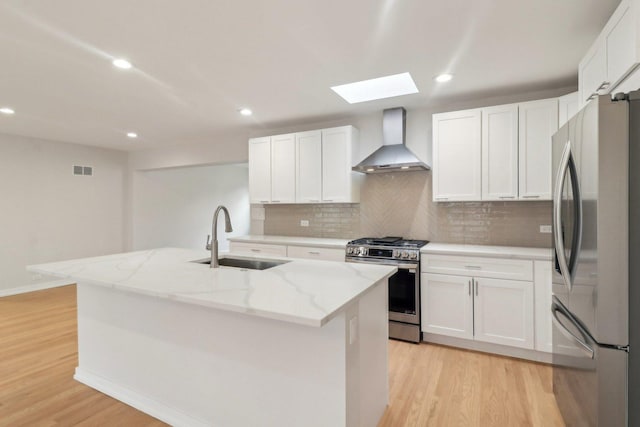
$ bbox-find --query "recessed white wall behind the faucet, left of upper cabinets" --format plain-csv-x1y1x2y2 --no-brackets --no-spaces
132,164,250,250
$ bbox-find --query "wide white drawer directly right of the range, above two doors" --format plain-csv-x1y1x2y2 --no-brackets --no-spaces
421,254,533,281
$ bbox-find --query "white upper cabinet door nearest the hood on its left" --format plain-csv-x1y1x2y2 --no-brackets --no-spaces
322,126,359,203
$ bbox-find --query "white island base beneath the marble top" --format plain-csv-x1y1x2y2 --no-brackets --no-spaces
75,279,388,427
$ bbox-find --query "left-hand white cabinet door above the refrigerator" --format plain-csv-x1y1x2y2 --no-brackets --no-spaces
578,38,608,106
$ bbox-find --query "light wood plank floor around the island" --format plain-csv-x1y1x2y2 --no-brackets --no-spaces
0,286,563,427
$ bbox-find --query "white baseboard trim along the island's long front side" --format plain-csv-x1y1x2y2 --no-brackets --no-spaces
73,366,209,427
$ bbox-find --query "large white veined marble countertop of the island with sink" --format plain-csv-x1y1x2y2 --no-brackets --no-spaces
27,248,396,327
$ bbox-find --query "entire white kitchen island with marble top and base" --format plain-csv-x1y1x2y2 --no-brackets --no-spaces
29,248,395,426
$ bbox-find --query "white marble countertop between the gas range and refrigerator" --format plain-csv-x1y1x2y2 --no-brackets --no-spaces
420,242,553,261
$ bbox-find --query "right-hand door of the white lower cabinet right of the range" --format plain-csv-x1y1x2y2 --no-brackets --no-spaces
473,278,534,349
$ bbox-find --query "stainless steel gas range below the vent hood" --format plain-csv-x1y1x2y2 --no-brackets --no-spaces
345,237,429,343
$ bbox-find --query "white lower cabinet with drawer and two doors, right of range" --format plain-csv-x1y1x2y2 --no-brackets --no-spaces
421,255,535,349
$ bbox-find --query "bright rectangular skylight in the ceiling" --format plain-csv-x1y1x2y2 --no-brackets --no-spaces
331,73,418,104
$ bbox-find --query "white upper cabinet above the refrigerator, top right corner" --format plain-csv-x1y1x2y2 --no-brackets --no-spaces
578,0,640,106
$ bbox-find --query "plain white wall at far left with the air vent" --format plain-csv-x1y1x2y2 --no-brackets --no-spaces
0,134,127,295
